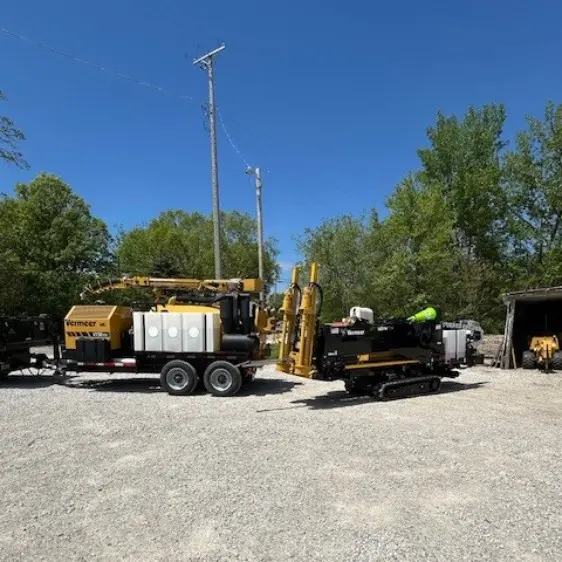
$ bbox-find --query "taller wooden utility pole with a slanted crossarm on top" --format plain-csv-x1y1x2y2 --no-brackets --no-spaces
193,45,225,279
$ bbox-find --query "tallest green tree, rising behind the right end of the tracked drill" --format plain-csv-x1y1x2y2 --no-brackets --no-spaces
417,104,508,329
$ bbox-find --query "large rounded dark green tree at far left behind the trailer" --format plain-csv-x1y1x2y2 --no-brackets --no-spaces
0,174,110,317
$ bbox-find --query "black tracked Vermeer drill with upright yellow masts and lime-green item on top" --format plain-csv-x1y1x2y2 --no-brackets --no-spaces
276,263,475,399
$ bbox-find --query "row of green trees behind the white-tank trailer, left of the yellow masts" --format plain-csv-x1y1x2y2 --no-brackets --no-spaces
0,174,279,318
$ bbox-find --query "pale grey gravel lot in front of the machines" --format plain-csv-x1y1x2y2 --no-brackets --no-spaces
0,360,562,562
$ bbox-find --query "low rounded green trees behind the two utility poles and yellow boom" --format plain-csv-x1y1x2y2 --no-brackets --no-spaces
116,210,279,287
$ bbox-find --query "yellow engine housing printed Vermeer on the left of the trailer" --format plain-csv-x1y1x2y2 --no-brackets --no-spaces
64,305,133,350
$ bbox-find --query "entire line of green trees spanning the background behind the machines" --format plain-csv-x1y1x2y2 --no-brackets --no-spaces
0,88,562,331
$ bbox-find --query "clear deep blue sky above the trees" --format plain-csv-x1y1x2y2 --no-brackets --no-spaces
0,0,562,280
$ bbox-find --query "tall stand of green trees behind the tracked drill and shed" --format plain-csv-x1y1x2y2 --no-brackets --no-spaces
298,102,562,332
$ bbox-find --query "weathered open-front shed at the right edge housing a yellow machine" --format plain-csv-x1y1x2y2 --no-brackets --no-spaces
494,287,562,369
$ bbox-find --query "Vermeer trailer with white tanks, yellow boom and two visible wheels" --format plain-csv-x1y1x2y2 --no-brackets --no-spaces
55,278,268,396
